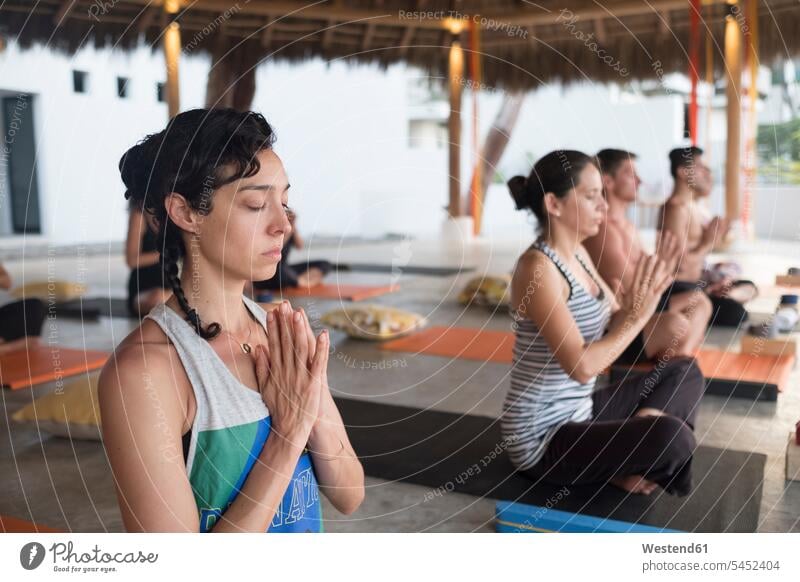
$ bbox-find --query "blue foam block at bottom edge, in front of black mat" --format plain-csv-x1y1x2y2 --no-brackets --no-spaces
495,501,679,533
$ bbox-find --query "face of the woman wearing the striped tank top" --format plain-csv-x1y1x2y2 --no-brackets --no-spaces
548,164,608,241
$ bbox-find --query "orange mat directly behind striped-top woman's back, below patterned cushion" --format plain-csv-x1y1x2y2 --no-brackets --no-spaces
380,326,514,364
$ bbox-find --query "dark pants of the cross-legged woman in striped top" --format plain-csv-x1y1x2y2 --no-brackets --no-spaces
524,358,704,496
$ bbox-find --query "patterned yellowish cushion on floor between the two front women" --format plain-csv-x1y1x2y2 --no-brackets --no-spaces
322,305,426,341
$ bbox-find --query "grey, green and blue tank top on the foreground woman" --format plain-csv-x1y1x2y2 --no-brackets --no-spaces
145,296,322,533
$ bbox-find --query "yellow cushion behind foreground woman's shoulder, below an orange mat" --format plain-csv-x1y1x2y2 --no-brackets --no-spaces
12,372,102,440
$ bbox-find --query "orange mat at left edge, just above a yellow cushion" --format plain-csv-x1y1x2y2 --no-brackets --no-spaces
0,346,108,390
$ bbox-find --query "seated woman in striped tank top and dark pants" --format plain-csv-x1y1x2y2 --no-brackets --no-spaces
501,150,704,495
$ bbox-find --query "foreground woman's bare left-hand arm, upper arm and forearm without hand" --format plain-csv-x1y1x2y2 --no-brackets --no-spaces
98,346,302,533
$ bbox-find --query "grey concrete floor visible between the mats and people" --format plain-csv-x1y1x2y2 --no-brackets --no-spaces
0,240,800,532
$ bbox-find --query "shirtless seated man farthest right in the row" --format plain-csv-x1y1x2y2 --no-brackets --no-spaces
659,146,758,327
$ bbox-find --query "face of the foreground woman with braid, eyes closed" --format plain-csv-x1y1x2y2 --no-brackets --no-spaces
192,150,292,281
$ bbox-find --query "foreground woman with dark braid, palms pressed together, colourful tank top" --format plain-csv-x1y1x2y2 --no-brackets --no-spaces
98,109,364,533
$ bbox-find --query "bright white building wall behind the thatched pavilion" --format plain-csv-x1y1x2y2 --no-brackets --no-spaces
0,44,768,244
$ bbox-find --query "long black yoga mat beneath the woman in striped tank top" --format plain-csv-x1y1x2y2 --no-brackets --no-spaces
337,398,766,532
